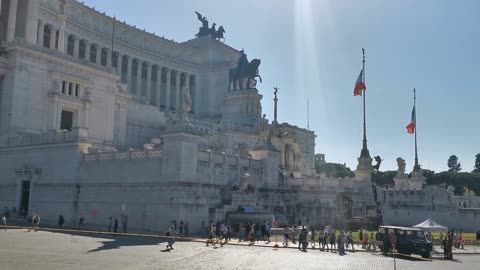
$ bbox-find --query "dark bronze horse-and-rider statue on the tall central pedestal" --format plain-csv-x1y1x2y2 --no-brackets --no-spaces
229,49,262,90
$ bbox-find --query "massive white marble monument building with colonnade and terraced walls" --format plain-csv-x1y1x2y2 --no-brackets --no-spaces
5,0,470,234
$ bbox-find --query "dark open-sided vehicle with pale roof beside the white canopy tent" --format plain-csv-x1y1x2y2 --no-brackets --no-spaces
376,226,433,258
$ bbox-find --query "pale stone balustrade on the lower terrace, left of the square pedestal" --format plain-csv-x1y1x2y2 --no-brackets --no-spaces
83,149,162,161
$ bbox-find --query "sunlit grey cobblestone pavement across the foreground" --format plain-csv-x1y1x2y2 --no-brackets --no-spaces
0,229,480,270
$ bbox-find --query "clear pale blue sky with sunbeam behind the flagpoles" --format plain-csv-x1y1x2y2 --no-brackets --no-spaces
84,0,480,171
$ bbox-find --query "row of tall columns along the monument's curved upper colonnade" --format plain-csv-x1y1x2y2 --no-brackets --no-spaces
56,32,197,111
